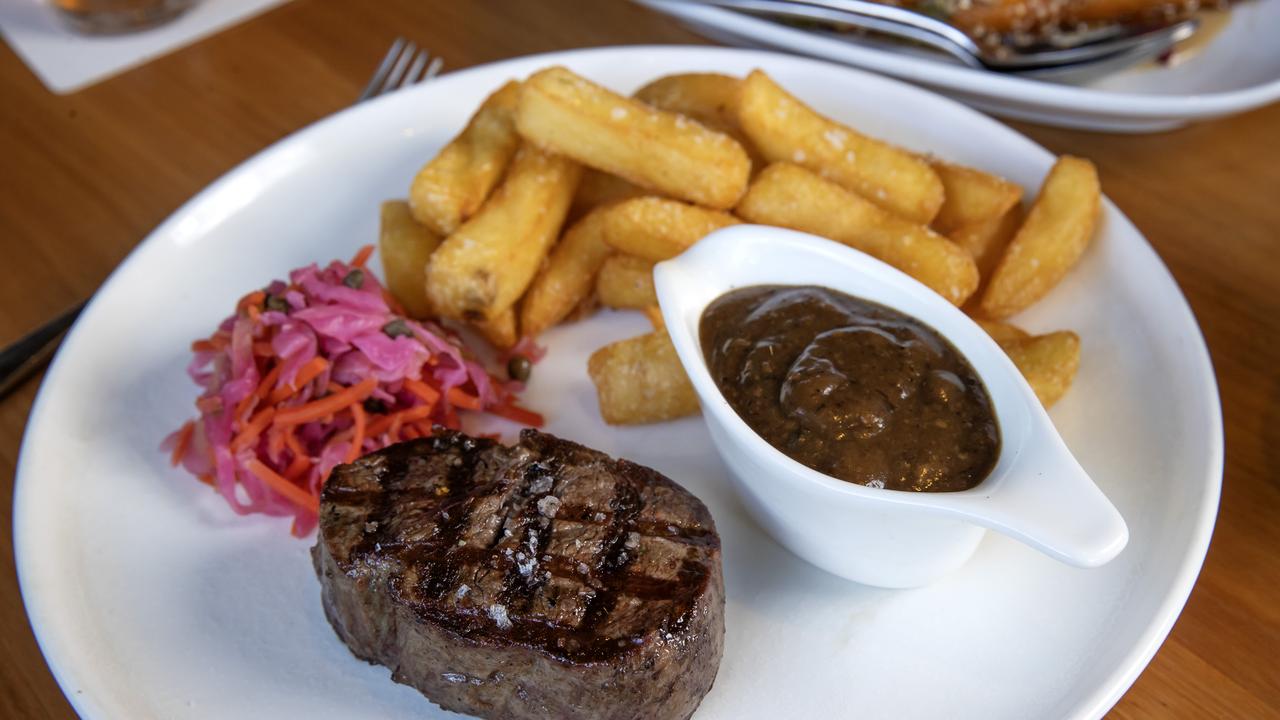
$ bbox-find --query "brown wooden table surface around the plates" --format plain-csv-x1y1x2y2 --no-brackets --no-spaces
0,0,1280,719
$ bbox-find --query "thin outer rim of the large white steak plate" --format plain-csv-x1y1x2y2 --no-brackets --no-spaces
13,45,1225,719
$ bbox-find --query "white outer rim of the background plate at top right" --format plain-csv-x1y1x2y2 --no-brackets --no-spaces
632,0,1280,122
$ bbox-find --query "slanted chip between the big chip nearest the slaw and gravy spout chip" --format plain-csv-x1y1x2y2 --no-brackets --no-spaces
520,209,613,337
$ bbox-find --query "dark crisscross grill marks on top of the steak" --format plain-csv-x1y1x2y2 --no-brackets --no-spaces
323,429,719,664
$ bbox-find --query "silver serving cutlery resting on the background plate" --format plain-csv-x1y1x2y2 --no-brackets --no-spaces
667,0,1199,82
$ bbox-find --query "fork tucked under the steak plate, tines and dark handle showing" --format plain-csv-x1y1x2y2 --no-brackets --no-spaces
0,37,444,400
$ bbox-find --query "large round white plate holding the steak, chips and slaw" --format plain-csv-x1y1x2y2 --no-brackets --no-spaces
14,47,1222,720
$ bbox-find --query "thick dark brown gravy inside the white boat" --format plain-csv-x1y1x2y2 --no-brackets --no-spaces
699,286,1000,492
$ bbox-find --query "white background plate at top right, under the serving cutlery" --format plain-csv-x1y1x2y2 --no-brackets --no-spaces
635,0,1280,132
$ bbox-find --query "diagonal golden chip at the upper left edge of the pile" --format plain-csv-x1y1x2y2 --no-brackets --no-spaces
408,82,520,236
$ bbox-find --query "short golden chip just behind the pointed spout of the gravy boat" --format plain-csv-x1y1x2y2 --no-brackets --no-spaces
600,197,741,263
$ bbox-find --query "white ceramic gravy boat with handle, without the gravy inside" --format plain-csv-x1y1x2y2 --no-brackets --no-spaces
654,225,1129,588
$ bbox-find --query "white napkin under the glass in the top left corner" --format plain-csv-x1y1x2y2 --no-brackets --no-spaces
0,0,287,94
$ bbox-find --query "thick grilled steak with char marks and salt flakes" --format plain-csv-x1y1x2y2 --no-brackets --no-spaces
312,430,724,720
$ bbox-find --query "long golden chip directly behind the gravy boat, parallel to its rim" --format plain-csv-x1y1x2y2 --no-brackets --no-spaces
736,163,978,305
